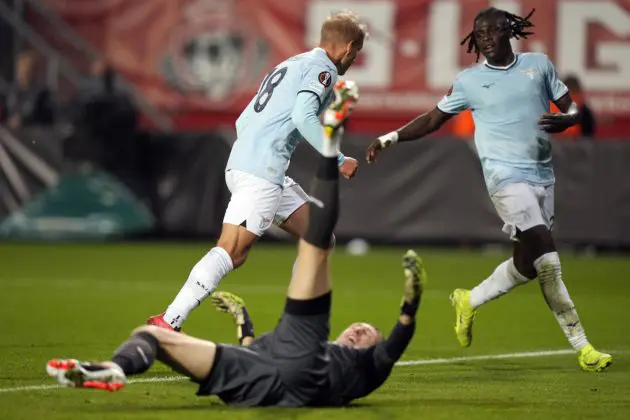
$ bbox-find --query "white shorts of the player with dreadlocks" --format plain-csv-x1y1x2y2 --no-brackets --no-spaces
490,183,554,240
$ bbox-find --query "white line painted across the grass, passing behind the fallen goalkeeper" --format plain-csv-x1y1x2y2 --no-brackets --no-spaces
0,350,592,394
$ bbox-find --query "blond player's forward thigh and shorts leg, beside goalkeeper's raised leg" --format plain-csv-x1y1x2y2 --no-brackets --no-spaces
274,176,309,239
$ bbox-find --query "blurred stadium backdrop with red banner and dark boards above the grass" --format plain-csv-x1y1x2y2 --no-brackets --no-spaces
0,0,630,249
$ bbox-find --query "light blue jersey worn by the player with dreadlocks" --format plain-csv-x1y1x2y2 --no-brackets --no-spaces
438,53,568,195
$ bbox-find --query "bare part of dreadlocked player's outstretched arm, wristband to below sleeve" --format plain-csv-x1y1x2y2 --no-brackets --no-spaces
365,106,455,163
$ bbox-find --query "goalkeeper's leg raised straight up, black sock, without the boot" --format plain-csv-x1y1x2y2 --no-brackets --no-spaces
256,151,339,405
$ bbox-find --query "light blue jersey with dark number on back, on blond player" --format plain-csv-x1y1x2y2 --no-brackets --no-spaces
226,48,337,185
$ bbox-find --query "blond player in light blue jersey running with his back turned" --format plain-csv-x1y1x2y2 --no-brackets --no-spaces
147,12,367,330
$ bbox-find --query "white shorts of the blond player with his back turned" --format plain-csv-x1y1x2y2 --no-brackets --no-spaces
223,170,309,236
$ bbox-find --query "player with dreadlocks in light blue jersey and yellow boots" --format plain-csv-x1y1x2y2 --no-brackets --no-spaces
367,8,612,371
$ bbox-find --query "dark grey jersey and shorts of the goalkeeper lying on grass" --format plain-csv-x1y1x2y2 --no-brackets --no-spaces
198,313,415,407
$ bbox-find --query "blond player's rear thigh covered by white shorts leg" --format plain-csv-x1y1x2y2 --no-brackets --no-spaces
223,170,282,236
